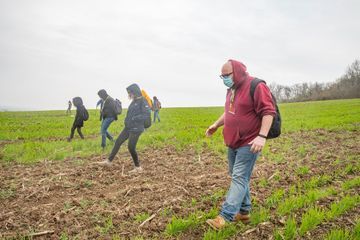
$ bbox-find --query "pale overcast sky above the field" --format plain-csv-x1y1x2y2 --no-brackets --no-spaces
0,0,360,109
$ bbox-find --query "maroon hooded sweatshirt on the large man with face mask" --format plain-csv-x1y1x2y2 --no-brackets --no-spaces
223,60,276,149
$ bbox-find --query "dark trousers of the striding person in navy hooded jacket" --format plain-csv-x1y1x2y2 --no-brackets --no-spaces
109,128,142,167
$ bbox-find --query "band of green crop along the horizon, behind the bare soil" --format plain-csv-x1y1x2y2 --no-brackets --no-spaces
0,99,360,163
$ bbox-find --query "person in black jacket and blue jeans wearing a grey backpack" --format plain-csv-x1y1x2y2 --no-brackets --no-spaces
98,89,117,149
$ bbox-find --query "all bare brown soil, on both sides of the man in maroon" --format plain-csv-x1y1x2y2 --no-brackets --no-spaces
0,131,360,239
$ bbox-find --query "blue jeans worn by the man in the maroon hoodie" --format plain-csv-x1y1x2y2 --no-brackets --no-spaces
220,146,259,221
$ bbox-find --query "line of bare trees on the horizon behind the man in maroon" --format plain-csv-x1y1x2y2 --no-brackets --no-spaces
269,60,360,102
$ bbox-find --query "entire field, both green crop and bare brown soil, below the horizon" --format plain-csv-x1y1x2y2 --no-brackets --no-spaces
0,99,360,239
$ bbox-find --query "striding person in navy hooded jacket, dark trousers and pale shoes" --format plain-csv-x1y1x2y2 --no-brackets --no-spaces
103,84,151,173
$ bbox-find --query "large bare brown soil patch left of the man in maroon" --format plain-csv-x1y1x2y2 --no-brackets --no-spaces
0,149,227,239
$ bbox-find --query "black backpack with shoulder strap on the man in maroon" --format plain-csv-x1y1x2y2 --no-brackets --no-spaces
250,78,281,139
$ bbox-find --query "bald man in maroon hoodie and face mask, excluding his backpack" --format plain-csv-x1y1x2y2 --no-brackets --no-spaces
206,60,276,229
